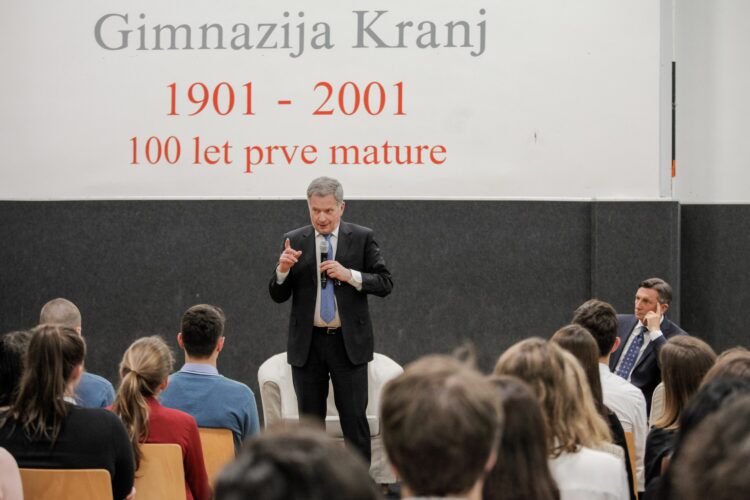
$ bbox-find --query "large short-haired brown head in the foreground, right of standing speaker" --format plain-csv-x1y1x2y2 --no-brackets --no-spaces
380,356,502,496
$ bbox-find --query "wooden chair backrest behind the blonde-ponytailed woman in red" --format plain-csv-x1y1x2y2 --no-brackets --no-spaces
135,443,185,500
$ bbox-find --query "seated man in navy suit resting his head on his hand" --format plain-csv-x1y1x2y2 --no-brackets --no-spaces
609,278,687,413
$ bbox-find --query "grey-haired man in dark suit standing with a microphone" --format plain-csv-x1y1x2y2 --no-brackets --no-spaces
269,177,393,461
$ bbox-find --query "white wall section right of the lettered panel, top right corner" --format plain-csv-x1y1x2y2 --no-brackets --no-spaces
674,0,750,203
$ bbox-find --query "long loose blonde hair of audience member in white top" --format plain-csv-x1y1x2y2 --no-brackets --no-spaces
494,338,612,457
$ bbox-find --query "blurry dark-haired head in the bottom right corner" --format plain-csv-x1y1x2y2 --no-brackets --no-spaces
670,395,750,500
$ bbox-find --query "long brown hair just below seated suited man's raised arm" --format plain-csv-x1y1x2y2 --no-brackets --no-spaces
654,335,716,429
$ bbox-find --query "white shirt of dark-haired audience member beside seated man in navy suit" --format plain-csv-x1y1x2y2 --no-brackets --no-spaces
599,363,648,491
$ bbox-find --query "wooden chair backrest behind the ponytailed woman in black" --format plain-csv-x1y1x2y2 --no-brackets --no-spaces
19,469,112,500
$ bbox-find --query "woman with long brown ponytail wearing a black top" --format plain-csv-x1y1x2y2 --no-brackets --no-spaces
0,325,134,500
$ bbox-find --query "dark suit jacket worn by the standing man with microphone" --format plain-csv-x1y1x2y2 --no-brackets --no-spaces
268,221,393,366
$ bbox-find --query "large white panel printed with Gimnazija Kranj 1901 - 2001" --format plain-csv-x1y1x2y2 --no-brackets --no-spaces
0,0,664,199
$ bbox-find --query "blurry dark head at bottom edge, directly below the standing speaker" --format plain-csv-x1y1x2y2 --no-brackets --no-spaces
214,425,381,500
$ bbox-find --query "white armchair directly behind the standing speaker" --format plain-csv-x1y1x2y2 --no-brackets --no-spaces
258,352,404,484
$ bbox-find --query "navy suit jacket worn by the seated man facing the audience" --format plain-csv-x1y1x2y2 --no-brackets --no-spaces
609,314,687,414
